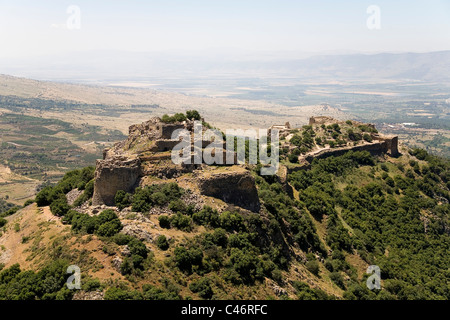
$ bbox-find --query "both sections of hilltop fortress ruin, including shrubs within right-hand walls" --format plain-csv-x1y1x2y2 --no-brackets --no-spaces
92,116,398,212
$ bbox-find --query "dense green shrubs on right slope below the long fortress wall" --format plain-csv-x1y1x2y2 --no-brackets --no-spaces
290,150,450,299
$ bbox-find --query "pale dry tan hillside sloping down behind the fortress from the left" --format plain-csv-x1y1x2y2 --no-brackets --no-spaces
0,74,345,133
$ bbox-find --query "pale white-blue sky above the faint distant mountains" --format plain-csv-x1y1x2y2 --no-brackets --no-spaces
0,0,450,58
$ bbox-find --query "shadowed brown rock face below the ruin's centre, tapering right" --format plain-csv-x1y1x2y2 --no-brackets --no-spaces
197,170,260,212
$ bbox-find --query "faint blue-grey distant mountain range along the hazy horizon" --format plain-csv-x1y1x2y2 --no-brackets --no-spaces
0,51,450,82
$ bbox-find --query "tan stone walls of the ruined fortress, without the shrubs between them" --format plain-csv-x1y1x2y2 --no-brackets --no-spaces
92,117,398,212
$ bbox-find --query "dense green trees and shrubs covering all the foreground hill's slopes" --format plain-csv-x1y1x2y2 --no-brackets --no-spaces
0,139,450,300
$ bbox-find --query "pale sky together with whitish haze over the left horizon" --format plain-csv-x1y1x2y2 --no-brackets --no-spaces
0,0,450,84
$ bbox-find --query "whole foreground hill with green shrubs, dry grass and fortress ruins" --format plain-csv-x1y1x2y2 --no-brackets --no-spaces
0,113,450,300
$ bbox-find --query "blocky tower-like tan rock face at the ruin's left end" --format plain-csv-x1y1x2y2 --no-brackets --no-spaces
92,156,141,206
